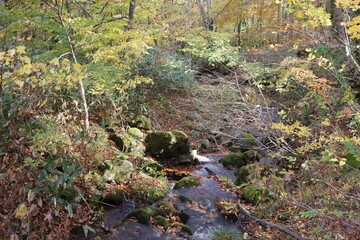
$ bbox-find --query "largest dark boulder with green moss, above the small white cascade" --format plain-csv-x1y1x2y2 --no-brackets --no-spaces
145,131,190,157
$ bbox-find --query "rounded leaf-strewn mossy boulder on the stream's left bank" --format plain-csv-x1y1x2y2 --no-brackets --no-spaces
129,173,169,203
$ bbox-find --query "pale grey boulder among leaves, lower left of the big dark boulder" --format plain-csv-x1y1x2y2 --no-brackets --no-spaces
103,160,134,183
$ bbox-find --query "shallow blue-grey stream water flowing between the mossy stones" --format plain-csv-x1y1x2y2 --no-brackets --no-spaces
93,155,240,240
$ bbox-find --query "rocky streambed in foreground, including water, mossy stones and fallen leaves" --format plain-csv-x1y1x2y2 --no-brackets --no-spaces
89,155,240,240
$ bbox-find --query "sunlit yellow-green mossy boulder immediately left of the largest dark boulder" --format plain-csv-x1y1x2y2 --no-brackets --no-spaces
110,132,146,156
